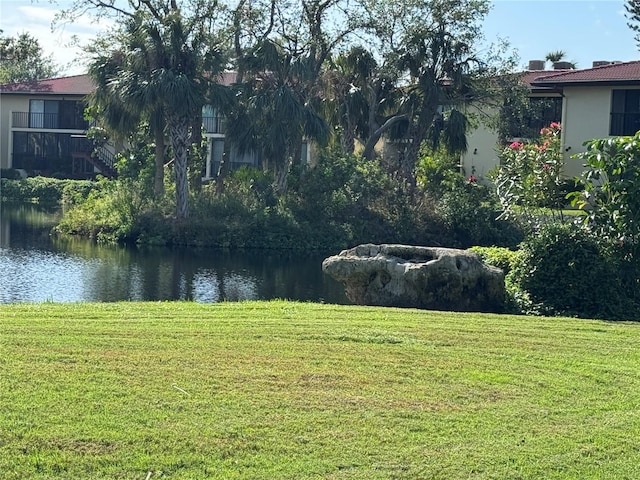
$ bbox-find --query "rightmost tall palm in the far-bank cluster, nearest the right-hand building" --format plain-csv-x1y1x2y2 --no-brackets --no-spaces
358,0,496,186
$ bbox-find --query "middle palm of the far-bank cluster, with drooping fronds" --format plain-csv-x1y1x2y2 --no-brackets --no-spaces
227,0,362,192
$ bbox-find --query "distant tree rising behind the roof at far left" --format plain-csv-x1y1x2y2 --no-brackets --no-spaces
0,30,58,83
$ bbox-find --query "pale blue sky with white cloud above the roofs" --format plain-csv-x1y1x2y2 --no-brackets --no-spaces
0,0,640,75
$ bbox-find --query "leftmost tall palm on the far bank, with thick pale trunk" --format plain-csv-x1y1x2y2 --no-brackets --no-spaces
66,0,230,220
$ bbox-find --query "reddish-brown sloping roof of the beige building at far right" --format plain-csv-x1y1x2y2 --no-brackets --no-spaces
531,60,640,87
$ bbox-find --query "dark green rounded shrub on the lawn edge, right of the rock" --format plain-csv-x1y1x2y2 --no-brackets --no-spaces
508,224,640,319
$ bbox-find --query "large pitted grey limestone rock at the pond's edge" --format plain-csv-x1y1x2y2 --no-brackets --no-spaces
322,244,505,312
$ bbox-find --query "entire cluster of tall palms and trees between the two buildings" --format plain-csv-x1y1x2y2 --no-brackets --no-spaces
56,0,508,218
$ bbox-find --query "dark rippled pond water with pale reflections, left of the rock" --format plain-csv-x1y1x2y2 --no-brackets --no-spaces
0,204,349,304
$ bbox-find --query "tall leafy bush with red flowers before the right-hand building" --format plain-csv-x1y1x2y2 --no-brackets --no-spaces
494,122,564,223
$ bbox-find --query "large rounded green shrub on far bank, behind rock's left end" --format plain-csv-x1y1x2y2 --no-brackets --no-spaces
282,151,441,248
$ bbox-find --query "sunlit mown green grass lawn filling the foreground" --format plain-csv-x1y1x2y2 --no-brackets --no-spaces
0,301,640,480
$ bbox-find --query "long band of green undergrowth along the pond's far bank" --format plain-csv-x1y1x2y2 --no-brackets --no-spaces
46,146,521,250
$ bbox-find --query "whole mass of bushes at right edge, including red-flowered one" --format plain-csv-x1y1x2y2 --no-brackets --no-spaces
483,127,640,319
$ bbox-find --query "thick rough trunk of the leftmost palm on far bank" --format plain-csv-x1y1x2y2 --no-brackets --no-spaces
169,114,190,220
